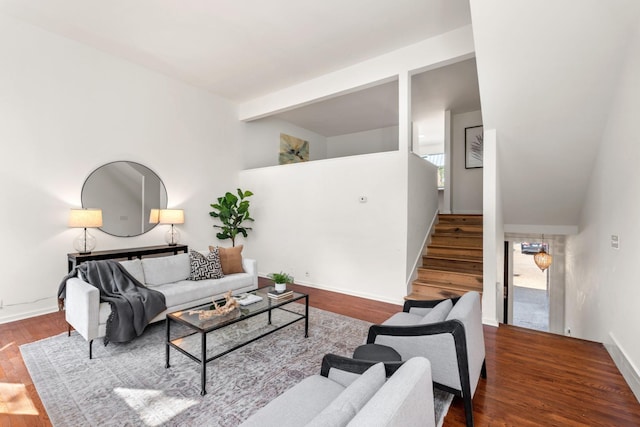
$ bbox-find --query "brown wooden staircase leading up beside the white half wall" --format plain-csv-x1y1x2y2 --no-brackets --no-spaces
406,214,482,300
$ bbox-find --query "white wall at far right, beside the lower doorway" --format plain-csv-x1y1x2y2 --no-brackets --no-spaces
565,20,640,399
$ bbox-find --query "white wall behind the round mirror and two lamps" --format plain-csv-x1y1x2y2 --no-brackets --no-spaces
0,15,241,322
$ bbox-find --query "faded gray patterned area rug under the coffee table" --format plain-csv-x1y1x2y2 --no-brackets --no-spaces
20,304,453,427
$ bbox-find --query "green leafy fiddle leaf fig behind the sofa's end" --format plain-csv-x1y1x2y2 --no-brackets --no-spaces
209,188,254,246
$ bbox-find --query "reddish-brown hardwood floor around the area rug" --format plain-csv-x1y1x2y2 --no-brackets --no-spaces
0,286,640,427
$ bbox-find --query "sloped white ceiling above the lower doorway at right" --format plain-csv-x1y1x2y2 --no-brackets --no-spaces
471,0,640,226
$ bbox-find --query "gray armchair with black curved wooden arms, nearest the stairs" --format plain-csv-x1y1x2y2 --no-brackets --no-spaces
367,292,486,426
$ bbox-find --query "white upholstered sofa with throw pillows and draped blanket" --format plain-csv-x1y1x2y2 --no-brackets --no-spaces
65,251,258,358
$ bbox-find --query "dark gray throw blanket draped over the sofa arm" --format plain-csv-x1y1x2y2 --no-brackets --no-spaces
58,260,167,345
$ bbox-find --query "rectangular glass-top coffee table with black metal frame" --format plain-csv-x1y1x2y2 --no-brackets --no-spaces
165,288,309,396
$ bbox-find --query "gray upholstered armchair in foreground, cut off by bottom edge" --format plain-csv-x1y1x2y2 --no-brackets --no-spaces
241,354,436,427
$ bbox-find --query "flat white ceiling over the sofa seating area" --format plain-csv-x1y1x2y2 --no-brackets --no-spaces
0,0,471,102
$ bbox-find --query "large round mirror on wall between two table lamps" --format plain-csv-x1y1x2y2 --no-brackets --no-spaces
82,161,167,237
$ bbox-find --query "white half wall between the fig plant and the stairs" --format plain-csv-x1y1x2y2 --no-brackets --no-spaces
240,152,406,304
